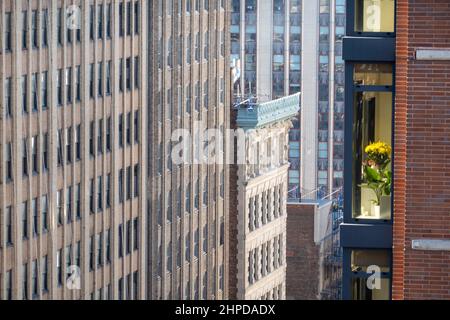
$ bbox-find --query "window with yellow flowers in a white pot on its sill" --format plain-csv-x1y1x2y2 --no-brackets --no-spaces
352,92,392,220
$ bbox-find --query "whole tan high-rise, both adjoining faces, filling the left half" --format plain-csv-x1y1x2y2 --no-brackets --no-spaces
0,0,229,300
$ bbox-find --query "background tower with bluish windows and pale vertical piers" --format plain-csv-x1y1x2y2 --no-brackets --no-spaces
230,0,345,199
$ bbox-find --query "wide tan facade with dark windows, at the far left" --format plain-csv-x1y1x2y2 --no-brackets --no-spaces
0,1,147,299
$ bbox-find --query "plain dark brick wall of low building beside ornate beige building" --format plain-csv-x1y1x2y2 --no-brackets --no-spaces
286,204,319,300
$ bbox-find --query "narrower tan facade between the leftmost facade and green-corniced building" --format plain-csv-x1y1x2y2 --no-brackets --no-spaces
147,0,230,300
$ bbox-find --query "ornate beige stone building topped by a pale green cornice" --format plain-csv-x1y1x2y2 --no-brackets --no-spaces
230,95,300,300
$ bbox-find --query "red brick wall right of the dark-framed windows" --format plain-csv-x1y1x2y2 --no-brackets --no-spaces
393,0,450,299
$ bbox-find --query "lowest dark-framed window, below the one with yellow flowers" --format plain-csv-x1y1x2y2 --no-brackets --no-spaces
350,250,391,300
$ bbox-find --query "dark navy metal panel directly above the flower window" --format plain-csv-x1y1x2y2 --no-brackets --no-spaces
342,37,395,62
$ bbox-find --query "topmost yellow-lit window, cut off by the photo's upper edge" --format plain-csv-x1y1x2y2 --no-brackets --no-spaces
354,0,395,32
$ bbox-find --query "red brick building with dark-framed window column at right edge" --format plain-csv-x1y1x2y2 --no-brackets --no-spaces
341,0,450,300
